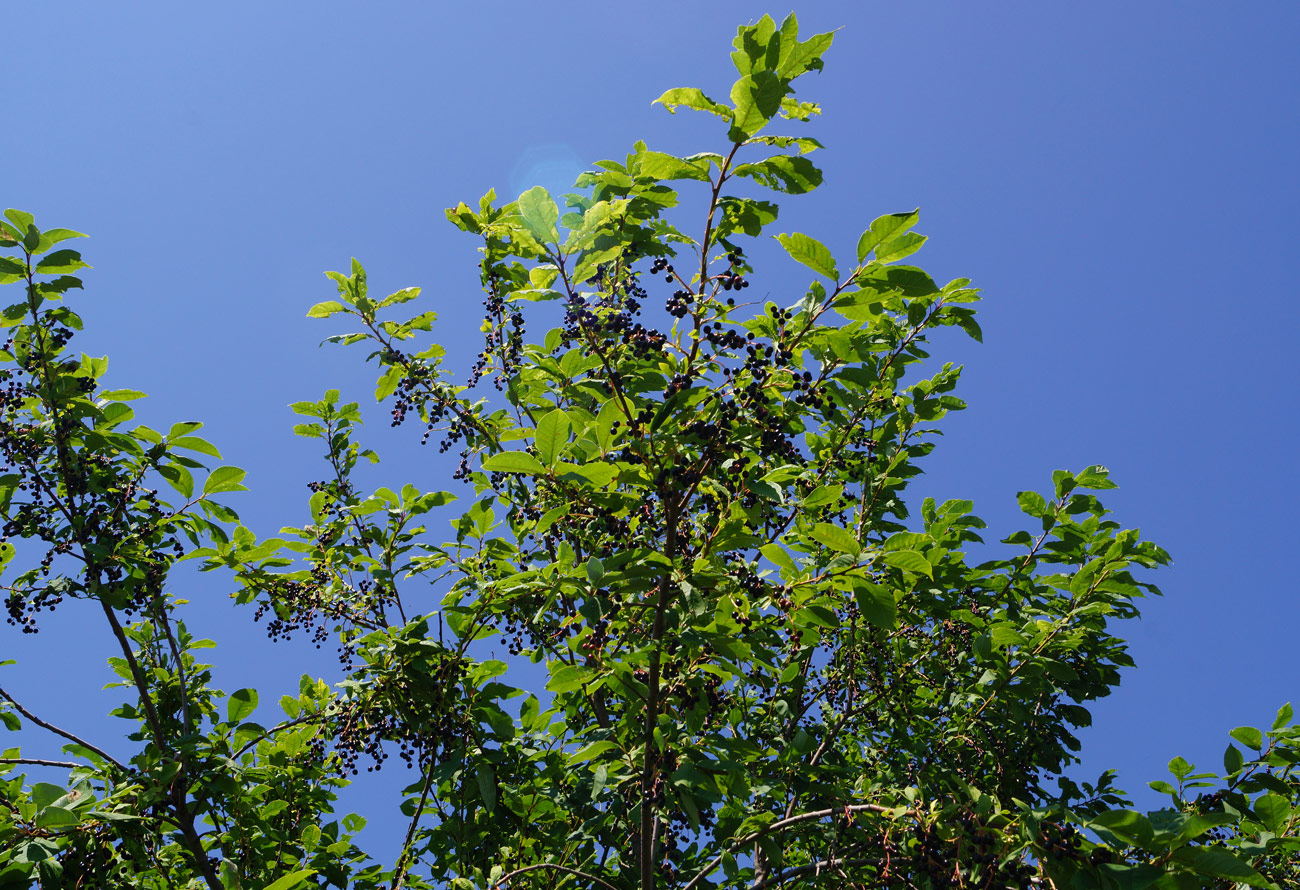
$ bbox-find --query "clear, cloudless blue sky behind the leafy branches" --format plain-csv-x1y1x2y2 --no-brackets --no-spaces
0,0,1300,852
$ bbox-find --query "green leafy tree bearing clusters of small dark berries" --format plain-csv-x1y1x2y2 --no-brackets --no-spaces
0,16,1300,890
